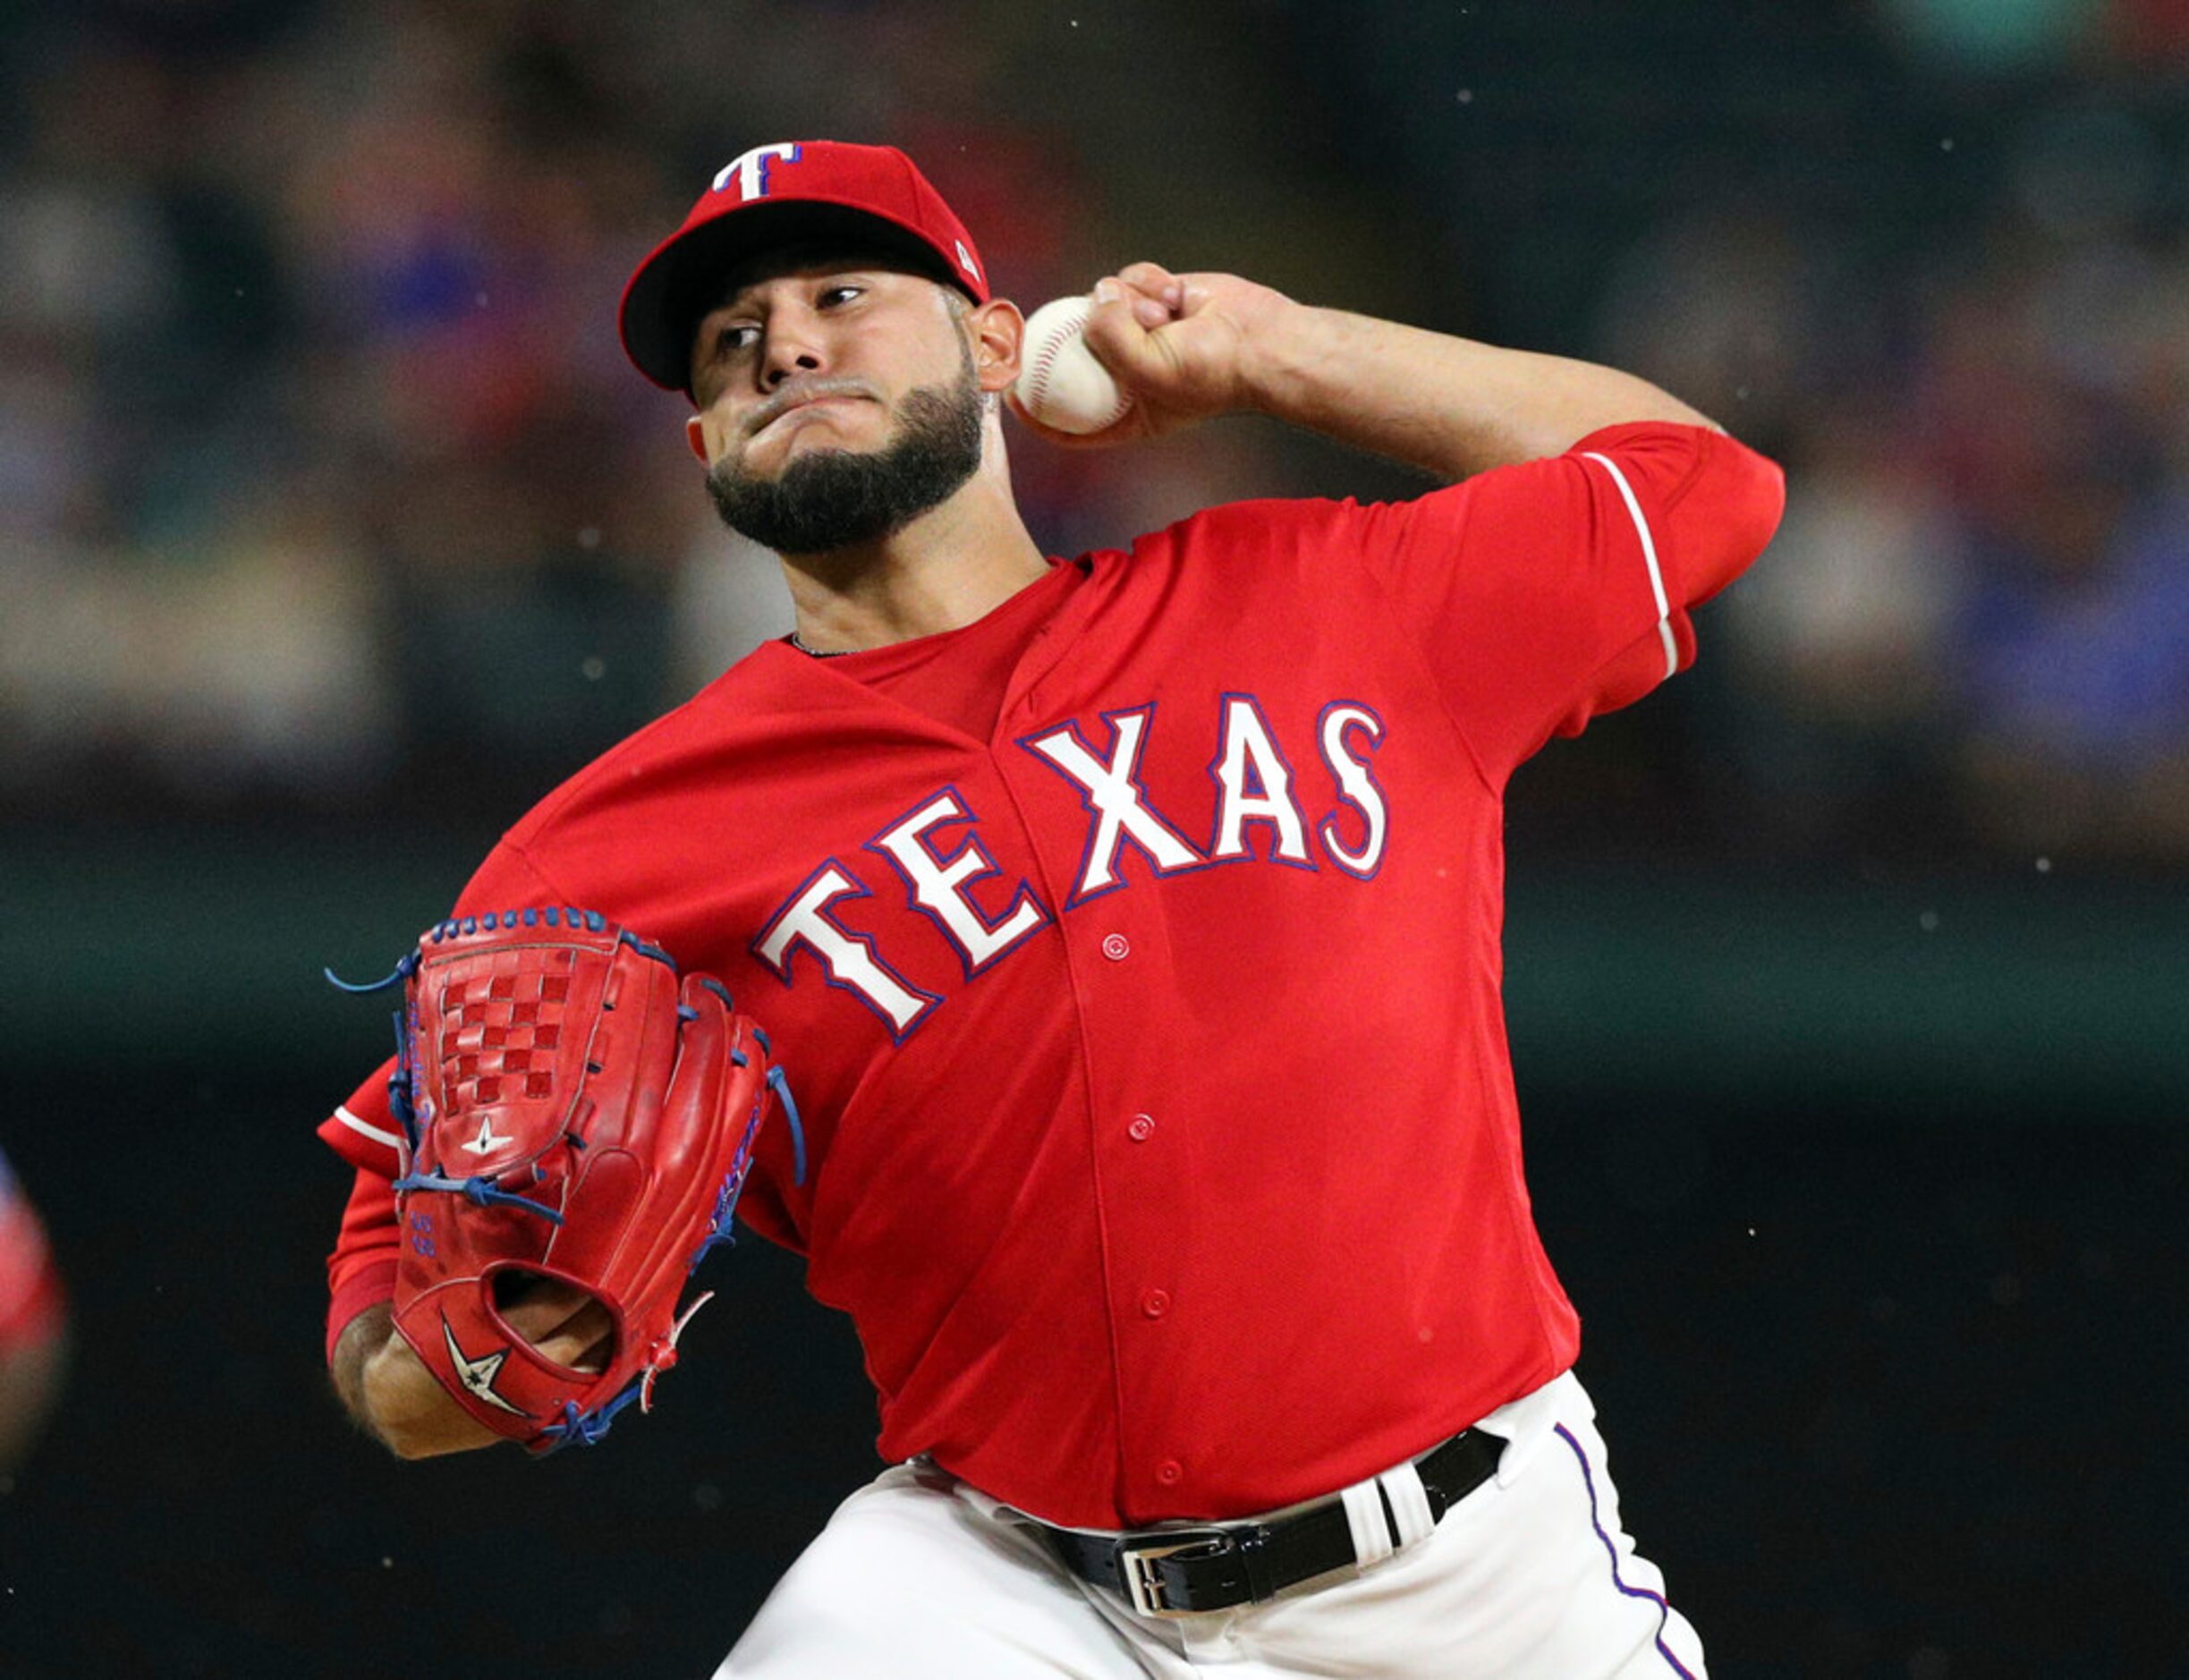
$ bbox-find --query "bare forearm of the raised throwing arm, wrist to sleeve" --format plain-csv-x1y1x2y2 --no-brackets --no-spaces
1243,304,1714,479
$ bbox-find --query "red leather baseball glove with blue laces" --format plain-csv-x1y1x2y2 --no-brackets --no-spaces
324,909,805,1452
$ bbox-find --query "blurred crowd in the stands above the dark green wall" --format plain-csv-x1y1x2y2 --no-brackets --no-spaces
0,0,2189,870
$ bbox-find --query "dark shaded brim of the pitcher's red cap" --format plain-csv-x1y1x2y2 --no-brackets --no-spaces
620,199,979,395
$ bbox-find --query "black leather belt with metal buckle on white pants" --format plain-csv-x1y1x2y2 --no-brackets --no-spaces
1035,1428,1504,1616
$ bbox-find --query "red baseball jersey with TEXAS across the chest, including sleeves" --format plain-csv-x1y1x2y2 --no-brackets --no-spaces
322,425,1782,1527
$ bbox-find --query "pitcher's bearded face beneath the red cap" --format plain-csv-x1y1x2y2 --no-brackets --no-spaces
691,259,983,554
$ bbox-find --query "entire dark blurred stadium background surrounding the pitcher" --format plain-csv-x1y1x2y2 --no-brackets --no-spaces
0,0,2189,1680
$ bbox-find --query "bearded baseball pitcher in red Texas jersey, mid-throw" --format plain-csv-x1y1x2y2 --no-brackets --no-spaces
322,140,1782,1680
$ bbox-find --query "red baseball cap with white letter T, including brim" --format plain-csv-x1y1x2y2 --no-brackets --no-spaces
617,140,988,392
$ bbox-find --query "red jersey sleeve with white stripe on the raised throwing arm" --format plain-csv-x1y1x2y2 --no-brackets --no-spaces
1362,423,1784,786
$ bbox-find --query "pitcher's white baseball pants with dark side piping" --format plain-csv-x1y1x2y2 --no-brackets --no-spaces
716,1373,1705,1680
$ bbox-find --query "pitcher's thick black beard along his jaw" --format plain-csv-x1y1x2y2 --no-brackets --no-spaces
707,368,980,554
